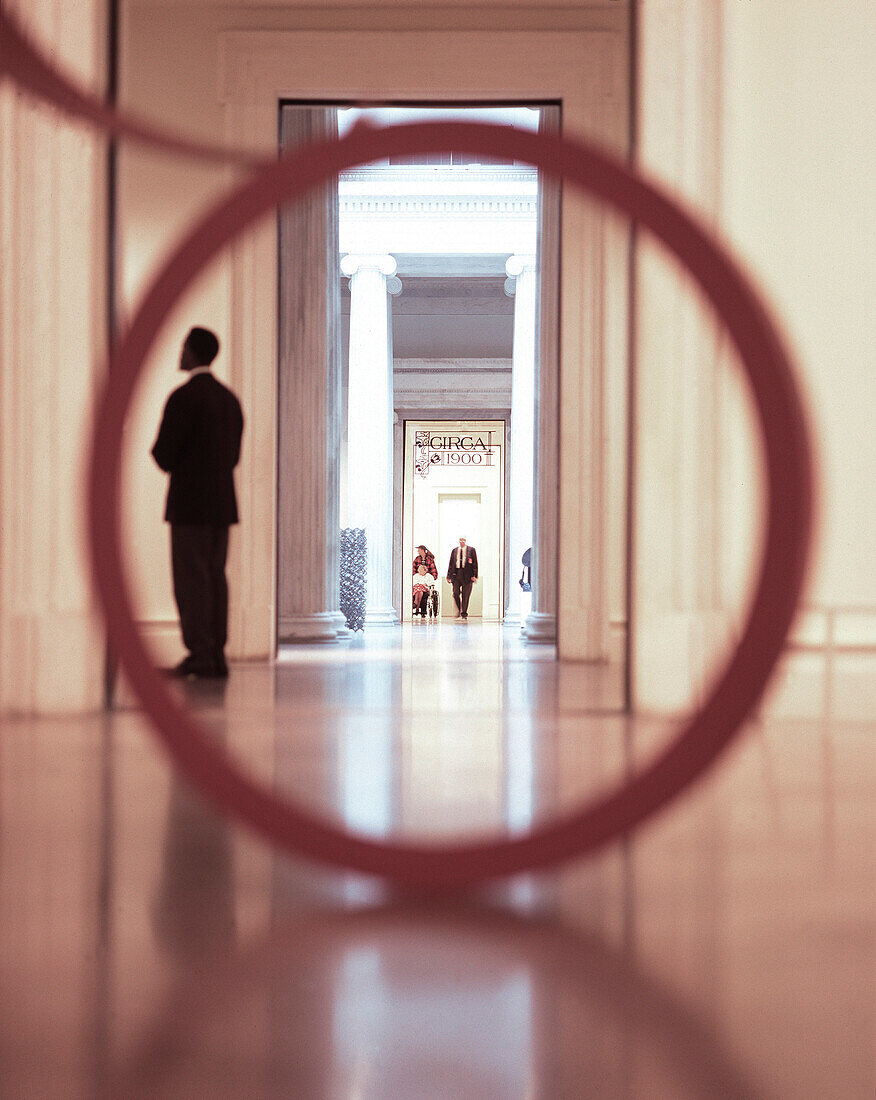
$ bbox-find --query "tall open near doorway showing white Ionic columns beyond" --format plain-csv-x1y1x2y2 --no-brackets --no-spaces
277,105,558,644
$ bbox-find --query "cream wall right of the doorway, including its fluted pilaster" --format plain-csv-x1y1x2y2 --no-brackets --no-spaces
634,0,876,717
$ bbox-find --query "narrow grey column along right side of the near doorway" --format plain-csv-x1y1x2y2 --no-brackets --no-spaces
524,107,560,642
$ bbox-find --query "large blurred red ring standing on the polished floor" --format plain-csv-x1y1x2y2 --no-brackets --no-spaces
88,122,813,890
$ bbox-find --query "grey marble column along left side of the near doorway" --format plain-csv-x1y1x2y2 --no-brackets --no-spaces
277,107,349,642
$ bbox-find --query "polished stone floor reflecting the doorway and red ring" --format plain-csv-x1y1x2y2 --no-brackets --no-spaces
0,622,876,1100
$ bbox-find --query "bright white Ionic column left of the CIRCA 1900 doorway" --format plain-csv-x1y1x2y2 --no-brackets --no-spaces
341,255,402,626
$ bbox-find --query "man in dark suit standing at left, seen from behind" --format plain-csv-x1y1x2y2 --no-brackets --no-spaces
152,328,243,677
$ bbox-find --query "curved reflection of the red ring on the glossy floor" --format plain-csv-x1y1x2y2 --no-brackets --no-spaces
113,905,766,1100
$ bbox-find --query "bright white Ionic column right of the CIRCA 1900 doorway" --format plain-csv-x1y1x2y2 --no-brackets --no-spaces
505,256,536,623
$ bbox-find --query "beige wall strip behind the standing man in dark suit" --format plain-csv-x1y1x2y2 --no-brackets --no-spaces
117,4,237,664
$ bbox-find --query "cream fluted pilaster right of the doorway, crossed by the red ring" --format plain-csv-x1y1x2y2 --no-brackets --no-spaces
631,0,726,712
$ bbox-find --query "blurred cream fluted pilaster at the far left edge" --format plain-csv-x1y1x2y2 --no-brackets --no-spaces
0,0,107,714
